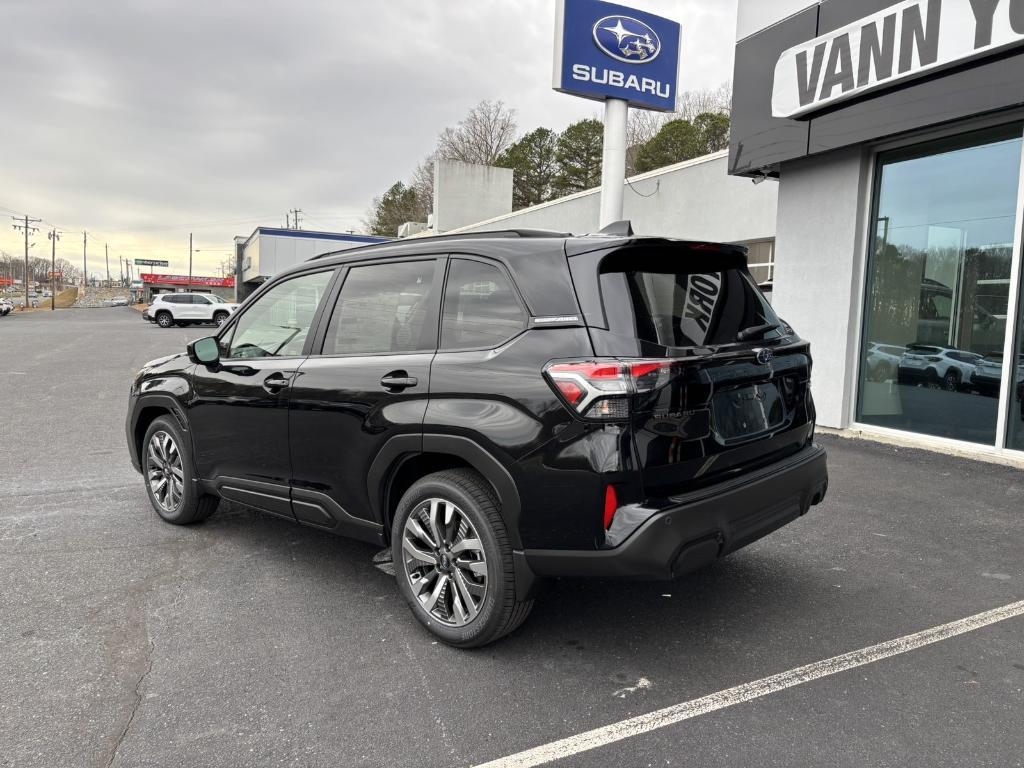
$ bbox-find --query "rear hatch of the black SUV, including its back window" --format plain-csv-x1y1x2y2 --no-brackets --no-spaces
569,241,814,498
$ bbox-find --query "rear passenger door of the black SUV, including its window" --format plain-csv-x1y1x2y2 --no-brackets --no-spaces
290,257,443,542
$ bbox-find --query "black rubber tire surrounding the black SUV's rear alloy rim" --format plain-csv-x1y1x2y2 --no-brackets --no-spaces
391,469,534,648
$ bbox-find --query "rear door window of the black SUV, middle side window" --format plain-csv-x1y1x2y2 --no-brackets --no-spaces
324,259,437,354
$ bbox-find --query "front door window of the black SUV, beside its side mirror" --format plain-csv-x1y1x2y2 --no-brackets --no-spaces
227,271,334,358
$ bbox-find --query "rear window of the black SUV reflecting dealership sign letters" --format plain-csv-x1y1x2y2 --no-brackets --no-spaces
601,247,783,347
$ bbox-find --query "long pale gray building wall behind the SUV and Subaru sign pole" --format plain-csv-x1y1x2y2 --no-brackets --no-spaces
457,152,778,243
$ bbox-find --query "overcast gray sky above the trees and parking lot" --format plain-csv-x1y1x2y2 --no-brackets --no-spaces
0,0,736,274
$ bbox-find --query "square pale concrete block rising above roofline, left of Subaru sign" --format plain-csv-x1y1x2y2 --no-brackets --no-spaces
433,160,512,233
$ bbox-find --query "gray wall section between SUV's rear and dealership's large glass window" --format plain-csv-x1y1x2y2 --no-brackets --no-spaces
772,148,870,428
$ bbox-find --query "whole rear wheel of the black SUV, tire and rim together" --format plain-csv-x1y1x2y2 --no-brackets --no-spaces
391,469,534,648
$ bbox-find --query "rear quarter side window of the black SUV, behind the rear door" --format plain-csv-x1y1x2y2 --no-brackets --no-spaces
441,259,526,349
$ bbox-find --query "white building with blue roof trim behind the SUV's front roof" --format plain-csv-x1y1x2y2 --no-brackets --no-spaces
234,226,390,301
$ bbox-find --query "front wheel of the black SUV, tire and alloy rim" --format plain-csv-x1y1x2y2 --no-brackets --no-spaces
139,416,219,525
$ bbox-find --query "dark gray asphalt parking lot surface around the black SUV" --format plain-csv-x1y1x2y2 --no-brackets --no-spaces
0,308,1024,768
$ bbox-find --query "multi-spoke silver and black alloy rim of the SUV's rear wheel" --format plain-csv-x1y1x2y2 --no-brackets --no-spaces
401,499,487,627
